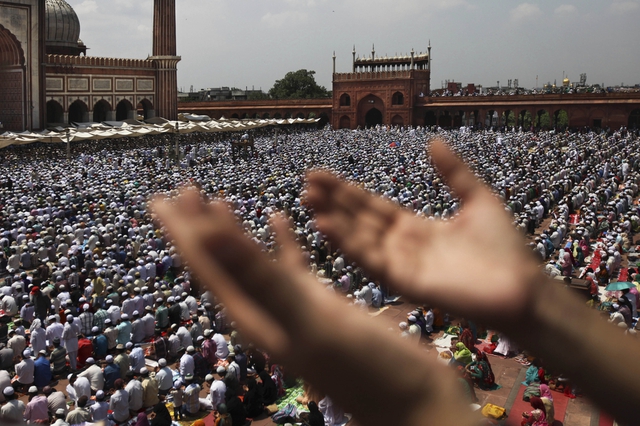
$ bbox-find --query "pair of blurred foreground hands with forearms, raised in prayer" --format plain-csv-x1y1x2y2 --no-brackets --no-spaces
150,141,640,426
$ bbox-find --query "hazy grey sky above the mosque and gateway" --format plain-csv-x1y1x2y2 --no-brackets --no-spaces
67,0,640,90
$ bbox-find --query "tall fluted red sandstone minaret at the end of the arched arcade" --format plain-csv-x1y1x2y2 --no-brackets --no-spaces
149,0,181,120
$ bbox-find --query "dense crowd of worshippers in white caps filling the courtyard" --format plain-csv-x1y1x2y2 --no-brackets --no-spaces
0,122,640,426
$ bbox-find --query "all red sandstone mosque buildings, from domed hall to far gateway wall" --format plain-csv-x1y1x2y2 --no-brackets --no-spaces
0,0,640,132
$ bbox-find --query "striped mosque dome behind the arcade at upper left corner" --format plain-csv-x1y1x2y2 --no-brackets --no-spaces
46,0,86,56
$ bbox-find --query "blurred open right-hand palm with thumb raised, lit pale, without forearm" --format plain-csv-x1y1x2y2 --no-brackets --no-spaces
308,141,538,325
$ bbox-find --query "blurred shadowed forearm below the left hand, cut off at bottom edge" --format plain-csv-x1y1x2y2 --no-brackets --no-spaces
294,300,479,426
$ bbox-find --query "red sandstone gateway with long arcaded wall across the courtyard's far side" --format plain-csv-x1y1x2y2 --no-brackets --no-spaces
178,43,640,129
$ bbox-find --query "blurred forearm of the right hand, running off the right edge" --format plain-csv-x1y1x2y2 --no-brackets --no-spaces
516,277,640,422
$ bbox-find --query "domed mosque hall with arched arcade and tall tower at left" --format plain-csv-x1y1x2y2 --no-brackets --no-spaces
0,0,180,131
